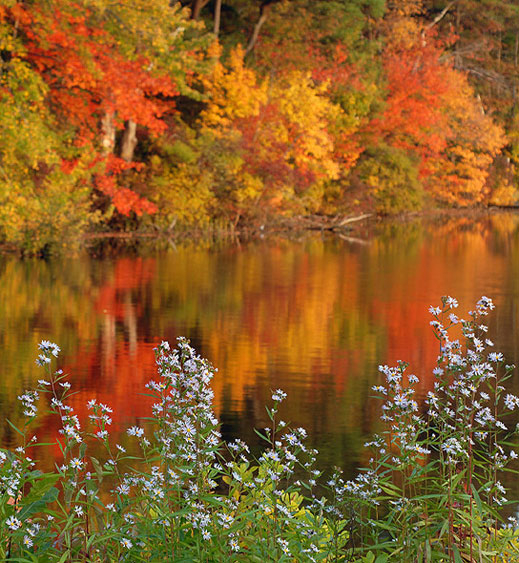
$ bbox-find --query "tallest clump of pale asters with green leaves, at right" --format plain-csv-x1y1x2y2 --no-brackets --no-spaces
346,297,519,562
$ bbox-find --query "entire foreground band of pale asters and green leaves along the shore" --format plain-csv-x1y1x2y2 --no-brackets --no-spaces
0,304,519,562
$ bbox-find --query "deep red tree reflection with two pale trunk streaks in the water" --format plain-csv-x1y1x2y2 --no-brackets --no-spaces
33,258,158,459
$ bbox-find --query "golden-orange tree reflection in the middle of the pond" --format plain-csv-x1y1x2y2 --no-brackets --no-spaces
204,240,386,428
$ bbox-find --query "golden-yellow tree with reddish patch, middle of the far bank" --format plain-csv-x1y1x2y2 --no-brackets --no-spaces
201,46,342,221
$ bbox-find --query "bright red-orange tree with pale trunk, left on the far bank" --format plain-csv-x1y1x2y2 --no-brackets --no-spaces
18,2,181,214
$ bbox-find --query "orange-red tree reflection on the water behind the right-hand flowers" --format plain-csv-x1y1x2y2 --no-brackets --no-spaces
372,220,508,396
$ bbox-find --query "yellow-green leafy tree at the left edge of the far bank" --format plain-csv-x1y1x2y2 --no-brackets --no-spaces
0,12,93,253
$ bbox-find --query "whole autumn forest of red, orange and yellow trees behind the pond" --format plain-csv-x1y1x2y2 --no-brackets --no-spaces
0,0,519,253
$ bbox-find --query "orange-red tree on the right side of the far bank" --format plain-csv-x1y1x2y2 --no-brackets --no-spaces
370,2,505,205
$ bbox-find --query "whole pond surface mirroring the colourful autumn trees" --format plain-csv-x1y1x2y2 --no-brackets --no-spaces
0,214,519,486
